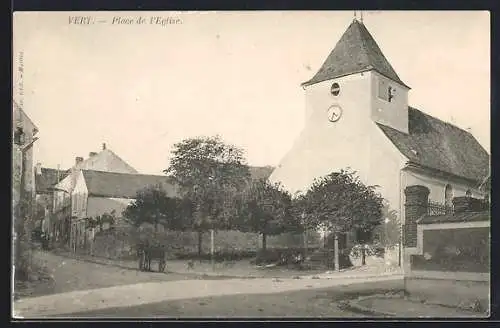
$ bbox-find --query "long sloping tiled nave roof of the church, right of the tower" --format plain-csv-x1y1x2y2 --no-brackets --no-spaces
377,107,490,182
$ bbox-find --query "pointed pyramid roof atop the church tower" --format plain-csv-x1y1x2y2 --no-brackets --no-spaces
302,19,409,88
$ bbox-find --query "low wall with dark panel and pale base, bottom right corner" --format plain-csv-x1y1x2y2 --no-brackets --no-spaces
405,223,490,310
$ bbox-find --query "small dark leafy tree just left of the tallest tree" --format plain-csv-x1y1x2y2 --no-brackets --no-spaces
123,186,179,232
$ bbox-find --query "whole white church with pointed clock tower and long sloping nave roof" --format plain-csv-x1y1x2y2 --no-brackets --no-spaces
270,19,490,263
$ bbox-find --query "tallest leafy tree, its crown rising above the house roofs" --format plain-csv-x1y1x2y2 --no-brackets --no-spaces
165,136,250,254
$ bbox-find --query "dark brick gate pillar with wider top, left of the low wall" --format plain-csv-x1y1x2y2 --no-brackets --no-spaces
403,185,430,247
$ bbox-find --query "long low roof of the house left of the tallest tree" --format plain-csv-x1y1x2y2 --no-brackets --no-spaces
82,170,177,199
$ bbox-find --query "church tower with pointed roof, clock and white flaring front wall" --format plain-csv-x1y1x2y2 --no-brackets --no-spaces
270,19,410,193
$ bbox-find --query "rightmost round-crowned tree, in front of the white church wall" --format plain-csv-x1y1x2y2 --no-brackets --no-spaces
301,170,383,268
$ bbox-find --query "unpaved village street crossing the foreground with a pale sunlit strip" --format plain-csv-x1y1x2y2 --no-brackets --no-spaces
14,253,403,318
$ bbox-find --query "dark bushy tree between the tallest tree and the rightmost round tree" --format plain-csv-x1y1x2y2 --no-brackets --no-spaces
234,180,299,251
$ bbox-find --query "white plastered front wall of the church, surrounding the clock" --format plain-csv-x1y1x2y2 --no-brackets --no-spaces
270,72,408,220
